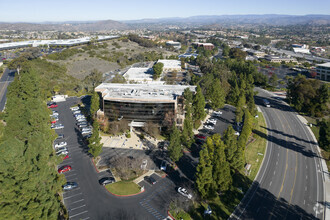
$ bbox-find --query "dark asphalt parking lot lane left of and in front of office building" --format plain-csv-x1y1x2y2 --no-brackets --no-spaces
55,98,180,220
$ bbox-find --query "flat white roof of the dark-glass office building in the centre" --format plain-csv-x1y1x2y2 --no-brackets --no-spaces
95,83,196,102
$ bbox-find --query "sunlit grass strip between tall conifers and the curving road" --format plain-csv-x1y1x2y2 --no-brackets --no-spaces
245,112,267,181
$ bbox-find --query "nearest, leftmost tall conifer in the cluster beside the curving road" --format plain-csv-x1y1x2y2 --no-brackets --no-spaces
196,148,213,199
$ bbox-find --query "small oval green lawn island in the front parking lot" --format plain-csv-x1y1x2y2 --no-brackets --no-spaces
105,181,141,196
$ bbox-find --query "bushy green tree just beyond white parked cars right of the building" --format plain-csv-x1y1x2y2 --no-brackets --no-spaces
208,80,225,110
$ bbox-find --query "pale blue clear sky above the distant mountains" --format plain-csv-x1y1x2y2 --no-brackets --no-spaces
0,0,330,22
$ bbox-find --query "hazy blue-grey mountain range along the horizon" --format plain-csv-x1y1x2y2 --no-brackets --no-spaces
0,14,330,32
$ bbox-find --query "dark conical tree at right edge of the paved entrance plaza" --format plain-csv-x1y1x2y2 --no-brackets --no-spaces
168,123,182,162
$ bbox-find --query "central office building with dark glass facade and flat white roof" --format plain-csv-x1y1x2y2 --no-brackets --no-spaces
95,83,196,127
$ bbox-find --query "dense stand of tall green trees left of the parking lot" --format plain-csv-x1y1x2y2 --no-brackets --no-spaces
0,69,65,219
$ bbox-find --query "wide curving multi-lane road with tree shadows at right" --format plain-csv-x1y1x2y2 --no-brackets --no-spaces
230,88,324,219
